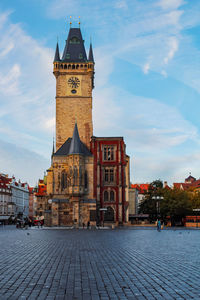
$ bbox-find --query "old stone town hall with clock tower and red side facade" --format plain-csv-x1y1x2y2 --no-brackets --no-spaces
45,28,130,226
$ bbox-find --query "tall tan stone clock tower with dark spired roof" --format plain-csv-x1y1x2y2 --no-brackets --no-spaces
53,28,94,151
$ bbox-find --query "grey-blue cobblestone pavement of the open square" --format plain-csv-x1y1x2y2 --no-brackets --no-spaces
0,226,200,300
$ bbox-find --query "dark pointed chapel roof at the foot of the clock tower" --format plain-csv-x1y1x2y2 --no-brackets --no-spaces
54,123,92,156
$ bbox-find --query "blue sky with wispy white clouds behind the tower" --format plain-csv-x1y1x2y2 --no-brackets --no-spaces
0,0,200,185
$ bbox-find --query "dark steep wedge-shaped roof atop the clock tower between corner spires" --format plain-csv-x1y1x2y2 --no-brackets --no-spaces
62,28,87,62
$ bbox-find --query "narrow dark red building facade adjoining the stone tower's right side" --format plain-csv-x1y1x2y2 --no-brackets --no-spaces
91,137,129,224
